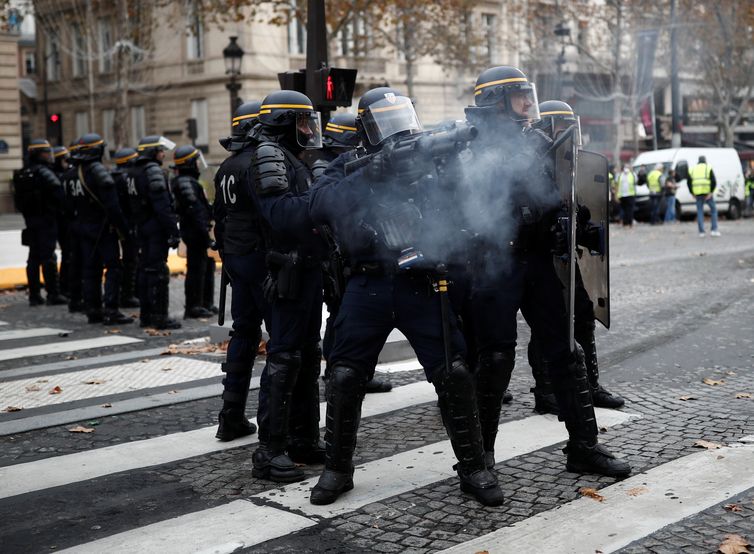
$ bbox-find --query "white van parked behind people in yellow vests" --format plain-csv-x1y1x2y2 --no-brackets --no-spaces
633,148,744,219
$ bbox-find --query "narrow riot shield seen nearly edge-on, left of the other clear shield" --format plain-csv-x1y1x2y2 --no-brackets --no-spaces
553,124,581,351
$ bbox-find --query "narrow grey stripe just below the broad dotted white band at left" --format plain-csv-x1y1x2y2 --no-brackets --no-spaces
0,377,259,436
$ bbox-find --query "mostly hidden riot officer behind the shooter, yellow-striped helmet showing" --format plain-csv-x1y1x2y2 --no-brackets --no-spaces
311,113,393,394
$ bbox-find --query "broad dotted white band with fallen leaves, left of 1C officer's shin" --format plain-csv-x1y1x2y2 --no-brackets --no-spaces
0,356,222,409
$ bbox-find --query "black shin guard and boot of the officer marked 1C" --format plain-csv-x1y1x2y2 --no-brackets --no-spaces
215,360,257,441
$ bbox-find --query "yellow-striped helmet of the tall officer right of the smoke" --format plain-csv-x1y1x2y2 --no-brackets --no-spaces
474,65,539,123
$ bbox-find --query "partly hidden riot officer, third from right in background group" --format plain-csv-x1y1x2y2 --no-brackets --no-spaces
111,148,139,308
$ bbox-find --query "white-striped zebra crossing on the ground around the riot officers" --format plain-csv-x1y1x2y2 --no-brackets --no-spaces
0,314,754,554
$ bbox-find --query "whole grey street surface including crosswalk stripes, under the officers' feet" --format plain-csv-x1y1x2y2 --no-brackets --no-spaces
0,220,754,554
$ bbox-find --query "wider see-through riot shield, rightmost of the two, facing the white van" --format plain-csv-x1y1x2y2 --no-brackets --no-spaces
576,150,610,329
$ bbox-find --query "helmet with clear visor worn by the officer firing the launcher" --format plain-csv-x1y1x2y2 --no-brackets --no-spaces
356,87,422,146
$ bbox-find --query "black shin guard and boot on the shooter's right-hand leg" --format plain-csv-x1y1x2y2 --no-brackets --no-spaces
433,360,505,506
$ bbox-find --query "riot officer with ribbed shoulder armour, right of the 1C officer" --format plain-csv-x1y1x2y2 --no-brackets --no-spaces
251,90,327,482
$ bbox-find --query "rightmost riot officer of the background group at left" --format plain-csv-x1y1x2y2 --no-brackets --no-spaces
170,144,215,319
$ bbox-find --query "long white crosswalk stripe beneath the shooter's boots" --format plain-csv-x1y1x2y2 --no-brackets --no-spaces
55,408,640,553
